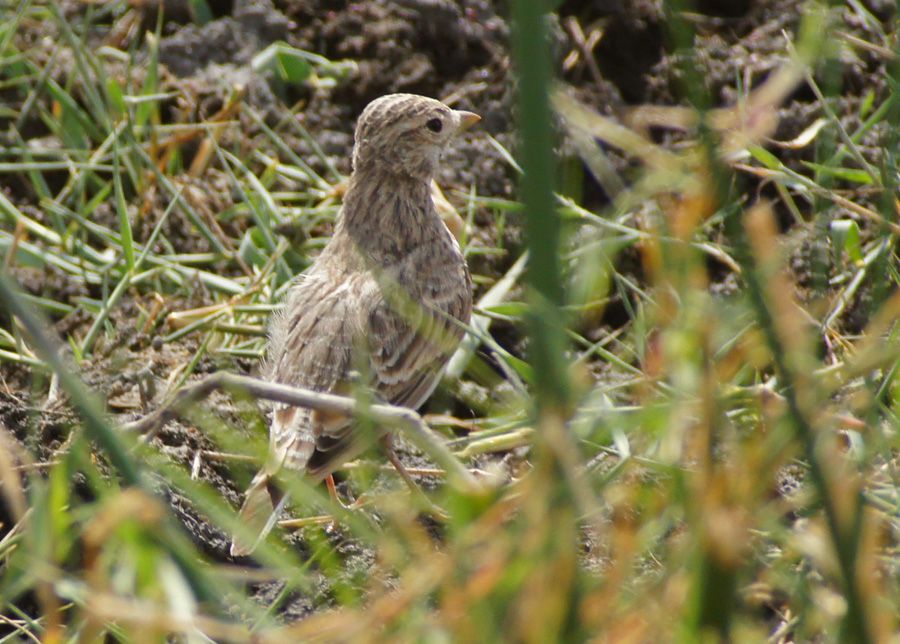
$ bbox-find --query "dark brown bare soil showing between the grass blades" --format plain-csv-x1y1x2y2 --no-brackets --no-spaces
0,0,896,619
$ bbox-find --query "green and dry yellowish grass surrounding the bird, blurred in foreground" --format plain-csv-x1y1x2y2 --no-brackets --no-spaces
0,1,900,642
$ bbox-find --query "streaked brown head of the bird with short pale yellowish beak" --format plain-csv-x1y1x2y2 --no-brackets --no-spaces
353,94,480,181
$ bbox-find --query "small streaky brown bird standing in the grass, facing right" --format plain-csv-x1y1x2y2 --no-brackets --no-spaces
231,94,479,556
